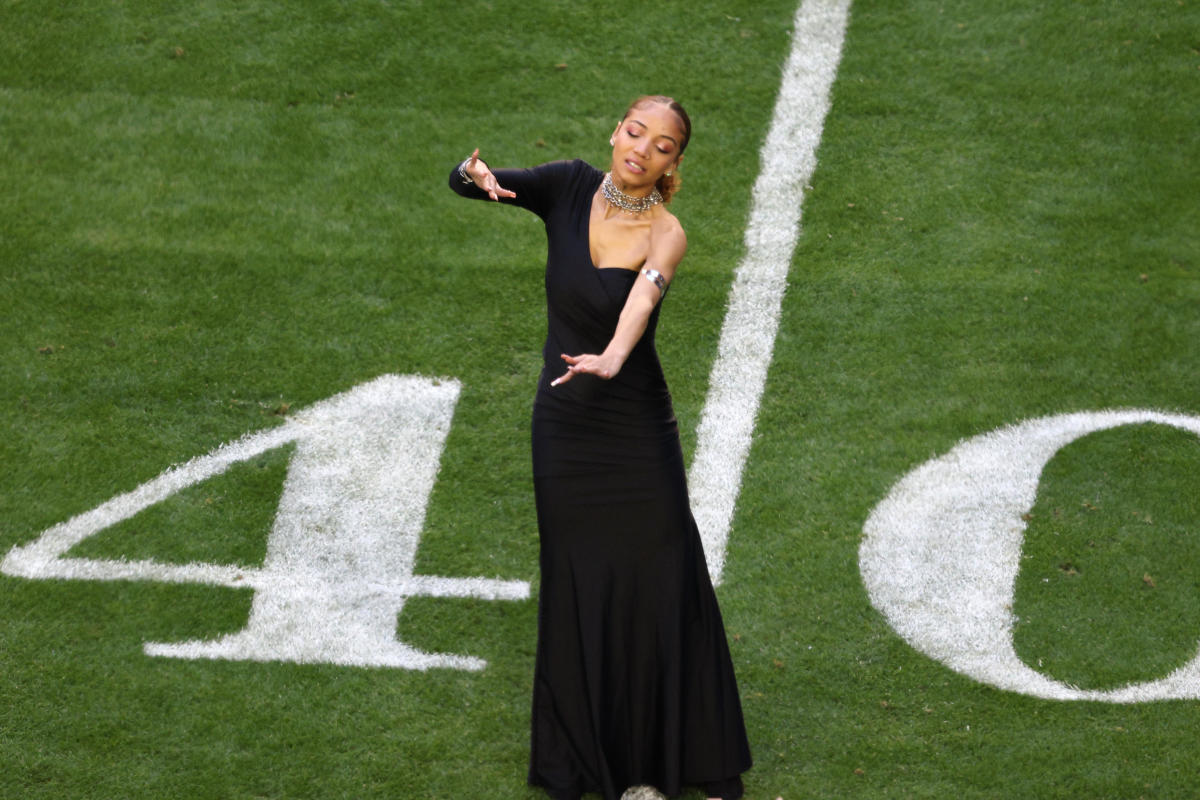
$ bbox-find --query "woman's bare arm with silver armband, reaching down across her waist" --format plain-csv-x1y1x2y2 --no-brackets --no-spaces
550,217,688,386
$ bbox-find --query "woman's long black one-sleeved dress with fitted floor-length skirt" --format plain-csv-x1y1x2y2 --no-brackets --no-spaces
450,161,750,800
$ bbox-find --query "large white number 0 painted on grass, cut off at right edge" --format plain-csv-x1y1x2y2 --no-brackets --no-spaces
859,410,1200,703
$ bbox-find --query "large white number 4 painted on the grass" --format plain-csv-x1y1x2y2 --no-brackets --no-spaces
0,375,529,669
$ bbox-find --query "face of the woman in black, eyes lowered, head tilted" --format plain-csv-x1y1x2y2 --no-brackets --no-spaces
612,103,684,191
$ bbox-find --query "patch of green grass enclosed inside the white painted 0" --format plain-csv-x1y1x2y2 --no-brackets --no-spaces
1014,426,1200,688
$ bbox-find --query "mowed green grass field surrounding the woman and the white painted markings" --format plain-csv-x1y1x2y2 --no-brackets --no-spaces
0,0,1200,800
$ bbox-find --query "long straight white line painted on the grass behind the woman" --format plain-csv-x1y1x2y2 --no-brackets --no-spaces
688,0,850,584
